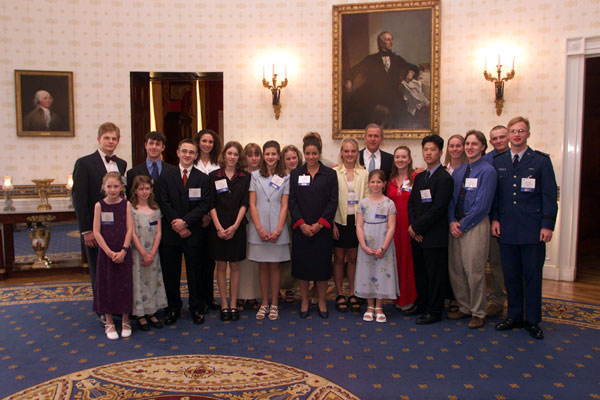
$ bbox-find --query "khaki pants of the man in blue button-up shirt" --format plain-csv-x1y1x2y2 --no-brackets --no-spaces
448,217,490,318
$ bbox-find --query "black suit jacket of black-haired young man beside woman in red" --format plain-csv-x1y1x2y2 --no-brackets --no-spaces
408,166,454,248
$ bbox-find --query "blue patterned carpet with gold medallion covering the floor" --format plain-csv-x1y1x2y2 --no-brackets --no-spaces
0,282,600,400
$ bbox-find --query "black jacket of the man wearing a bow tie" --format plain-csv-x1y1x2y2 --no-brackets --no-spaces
72,151,127,232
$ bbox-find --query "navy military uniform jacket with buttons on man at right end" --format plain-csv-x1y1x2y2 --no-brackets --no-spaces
491,147,558,244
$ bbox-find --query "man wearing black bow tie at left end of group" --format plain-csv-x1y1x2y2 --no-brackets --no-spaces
73,122,127,302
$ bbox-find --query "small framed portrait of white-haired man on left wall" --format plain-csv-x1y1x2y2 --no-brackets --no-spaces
15,70,75,136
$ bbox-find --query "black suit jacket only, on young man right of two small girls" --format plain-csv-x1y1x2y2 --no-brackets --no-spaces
160,166,210,246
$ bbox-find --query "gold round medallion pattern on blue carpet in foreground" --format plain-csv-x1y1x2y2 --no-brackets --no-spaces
6,355,358,400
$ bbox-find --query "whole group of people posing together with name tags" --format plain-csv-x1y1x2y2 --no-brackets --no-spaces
73,117,557,339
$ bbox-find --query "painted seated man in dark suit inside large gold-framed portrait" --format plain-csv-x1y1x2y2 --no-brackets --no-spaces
342,31,419,129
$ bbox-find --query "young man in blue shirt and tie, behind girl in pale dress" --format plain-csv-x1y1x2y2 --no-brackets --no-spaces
127,131,174,200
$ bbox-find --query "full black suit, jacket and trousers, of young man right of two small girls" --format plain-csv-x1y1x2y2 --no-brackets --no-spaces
160,166,210,313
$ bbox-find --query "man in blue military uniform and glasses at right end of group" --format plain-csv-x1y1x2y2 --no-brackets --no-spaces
491,117,558,339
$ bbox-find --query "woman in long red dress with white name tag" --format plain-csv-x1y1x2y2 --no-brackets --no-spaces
387,146,417,310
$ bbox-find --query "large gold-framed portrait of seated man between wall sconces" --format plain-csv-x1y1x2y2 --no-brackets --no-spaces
333,0,441,139
